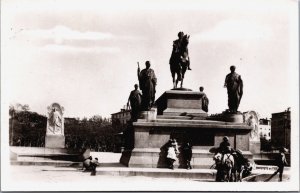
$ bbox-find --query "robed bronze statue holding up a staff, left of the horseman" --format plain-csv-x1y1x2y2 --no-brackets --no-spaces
138,61,157,111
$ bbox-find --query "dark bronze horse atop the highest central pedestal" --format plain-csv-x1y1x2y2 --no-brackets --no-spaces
170,35,190,88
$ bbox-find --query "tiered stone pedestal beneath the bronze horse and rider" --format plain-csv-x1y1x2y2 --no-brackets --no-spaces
120,90,252,168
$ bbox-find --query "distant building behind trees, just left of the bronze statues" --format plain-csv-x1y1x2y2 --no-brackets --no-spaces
111,105,131,129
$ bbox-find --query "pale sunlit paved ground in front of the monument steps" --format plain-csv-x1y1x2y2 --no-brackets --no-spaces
2,152,289,191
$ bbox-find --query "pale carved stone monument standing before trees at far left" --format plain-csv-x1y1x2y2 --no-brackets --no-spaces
45,103,65,148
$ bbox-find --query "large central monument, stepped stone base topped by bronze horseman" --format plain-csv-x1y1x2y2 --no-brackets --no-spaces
120,35,253,168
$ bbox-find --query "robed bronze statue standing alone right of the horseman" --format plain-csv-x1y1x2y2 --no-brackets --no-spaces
224,66,243,113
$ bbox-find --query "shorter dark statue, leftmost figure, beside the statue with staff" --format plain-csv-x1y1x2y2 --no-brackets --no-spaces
127,84,142,121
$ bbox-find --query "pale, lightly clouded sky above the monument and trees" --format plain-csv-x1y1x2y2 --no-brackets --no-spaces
1,0,299,118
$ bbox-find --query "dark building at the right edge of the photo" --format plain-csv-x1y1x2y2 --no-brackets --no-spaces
271,108,291,150
